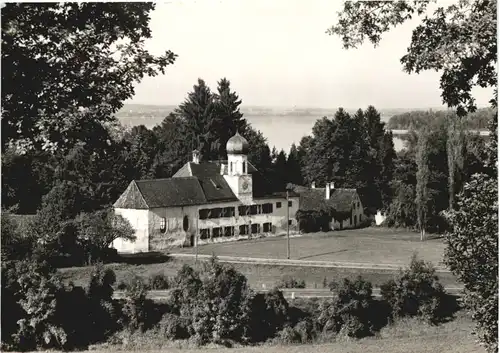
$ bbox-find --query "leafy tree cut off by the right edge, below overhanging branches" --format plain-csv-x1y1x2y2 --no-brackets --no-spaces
445,174,498,352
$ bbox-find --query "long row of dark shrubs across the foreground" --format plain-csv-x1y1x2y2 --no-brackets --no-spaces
2,253,458,350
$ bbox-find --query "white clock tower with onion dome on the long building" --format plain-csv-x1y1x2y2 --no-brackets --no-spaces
224,132,253,204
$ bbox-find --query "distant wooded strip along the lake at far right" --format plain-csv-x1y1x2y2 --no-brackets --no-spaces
387,107,494,130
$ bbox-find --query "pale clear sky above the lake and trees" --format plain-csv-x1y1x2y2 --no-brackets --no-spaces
127,0,491,108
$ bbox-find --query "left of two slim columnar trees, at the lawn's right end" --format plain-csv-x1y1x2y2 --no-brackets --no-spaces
415,131,430,240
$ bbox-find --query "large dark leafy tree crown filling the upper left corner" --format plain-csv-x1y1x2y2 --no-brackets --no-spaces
2,3,175,150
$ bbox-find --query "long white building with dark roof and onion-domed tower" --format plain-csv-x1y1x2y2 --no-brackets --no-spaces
113,132,299,253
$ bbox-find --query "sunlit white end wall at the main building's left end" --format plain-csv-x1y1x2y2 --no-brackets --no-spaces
112,208,149,253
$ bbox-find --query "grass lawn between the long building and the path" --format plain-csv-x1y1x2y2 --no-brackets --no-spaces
176,227,445,265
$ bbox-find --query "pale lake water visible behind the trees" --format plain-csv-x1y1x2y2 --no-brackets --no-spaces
119,115,404,153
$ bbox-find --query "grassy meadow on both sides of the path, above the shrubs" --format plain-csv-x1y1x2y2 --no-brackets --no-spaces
59,228,461,289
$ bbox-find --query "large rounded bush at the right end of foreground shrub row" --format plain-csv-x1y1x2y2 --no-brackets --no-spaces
380,255,445,323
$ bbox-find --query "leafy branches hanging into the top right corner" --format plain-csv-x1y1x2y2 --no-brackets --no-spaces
327,0,497,116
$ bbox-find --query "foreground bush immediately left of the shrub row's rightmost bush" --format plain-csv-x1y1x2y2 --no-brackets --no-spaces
318,277,373,337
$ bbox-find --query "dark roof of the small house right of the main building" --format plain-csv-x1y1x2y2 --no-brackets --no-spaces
295,187,357,213
